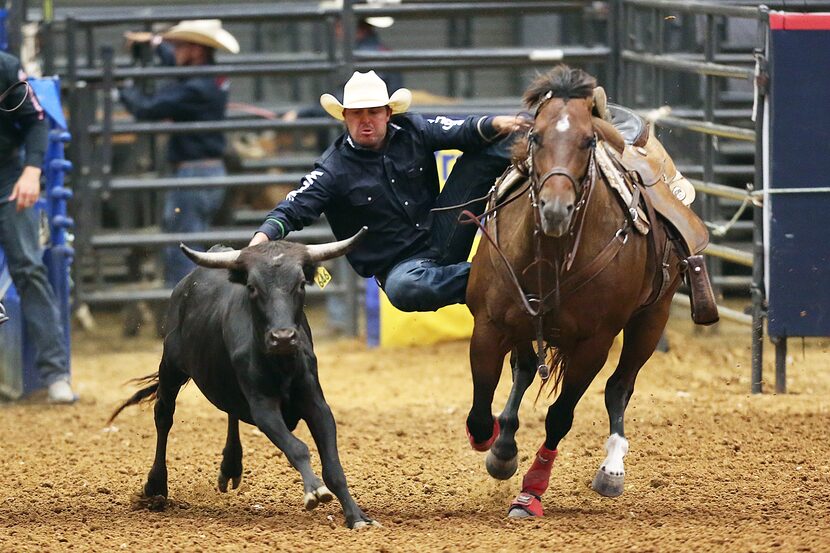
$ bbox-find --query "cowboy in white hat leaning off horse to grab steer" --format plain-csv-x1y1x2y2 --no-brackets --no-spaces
250,71,524,311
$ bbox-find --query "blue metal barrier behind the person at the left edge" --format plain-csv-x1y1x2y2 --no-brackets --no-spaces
0,78,74,398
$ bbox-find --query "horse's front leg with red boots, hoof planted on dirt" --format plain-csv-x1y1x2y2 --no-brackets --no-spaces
508,334,614,518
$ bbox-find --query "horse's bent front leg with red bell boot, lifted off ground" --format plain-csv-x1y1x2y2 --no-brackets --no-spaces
467,321,509,451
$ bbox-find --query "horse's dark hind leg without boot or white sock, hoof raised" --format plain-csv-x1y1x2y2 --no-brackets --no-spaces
485,343,536,480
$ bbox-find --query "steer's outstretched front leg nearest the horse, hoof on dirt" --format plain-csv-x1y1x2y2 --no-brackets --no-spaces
303,378,379,529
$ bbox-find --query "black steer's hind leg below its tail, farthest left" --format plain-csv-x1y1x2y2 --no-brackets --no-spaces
144,355,188,497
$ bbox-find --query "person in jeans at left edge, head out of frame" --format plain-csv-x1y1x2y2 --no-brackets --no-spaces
0,52,78,403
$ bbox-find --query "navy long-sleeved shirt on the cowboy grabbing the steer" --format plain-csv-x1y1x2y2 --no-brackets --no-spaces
259,113,497,277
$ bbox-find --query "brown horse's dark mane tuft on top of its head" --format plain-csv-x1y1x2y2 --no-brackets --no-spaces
512,64,597,170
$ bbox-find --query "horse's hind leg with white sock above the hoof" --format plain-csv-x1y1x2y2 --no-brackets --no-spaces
591,294,672,497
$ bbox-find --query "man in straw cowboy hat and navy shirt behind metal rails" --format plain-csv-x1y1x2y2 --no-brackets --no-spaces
119,19,239,286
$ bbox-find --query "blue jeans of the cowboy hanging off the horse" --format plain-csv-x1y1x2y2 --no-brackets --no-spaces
379,140,509,311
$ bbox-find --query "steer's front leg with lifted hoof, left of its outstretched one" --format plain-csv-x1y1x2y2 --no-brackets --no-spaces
245,390,332,510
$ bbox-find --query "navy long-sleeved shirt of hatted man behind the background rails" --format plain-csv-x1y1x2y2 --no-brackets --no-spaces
120,43,230,163
